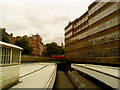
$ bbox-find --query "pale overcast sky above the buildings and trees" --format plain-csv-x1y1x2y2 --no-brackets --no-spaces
0,0,95,44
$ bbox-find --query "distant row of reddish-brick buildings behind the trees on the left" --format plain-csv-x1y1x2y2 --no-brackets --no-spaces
0,28,46,56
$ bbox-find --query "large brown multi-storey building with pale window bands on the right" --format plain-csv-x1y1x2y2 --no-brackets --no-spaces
65,1,120,64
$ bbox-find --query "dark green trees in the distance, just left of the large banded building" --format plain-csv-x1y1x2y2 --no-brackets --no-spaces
46,42,64,56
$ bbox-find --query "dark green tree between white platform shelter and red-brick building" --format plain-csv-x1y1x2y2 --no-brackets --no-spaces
15,37,32,55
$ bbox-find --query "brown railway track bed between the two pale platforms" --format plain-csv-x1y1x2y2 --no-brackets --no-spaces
53,70,102,90
